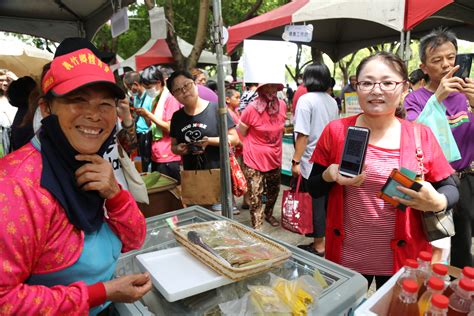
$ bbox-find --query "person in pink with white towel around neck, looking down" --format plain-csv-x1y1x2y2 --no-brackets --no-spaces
136,66,182,182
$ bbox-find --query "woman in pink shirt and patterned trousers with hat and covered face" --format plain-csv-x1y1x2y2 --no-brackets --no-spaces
239,83,286,229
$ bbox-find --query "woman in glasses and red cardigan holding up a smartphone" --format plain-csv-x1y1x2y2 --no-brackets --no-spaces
308,52,459,288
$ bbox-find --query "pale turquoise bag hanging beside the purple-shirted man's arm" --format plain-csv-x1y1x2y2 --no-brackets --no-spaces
416,95,461,162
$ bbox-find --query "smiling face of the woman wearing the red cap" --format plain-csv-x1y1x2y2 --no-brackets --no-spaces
46,85,117,154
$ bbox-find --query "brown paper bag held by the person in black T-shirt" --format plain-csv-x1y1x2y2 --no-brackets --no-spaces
181,169,221,205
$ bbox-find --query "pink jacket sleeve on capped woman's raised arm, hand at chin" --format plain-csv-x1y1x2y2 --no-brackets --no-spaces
105,190,146,253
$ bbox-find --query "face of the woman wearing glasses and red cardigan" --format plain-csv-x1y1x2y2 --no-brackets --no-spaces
357,57,408,116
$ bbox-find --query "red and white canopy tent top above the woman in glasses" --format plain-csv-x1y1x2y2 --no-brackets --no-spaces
227,0,474,60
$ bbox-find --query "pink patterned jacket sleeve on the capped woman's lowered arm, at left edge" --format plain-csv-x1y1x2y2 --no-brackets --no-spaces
0,177,89,315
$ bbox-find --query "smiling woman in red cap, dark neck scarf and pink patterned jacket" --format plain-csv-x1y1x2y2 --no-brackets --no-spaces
0,40,151,315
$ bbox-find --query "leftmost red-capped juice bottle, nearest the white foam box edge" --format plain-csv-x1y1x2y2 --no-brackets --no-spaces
387,279,419,316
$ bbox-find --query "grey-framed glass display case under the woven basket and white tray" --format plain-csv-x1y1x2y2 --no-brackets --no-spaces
114,206,367,315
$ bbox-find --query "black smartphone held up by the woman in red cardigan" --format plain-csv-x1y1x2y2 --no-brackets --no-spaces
339,126,370,178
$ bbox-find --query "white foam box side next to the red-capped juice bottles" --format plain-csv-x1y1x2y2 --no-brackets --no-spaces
354,268,405,316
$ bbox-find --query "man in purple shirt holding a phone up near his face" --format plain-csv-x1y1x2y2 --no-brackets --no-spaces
405,29,474,268
